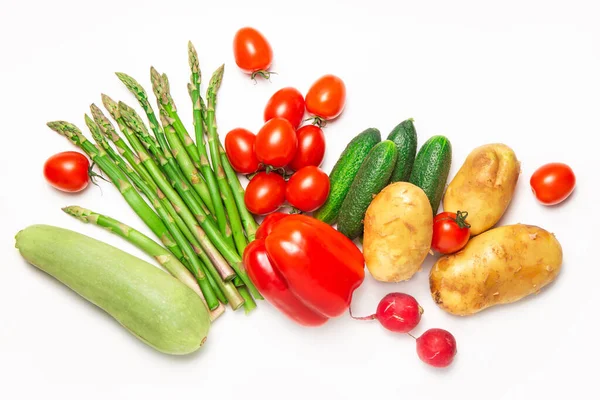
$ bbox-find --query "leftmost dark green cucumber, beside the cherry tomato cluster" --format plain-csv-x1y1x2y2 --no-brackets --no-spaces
314,128,381,224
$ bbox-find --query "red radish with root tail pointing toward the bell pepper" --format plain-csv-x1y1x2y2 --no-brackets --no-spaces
350,293,423,333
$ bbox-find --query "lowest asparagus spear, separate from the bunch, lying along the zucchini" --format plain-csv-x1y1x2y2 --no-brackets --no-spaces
62,206,225,321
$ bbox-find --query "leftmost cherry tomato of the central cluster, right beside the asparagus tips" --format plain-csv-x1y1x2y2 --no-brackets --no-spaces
225,128,259,174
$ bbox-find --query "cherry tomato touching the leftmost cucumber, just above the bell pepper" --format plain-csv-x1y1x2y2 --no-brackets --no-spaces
285,166,329,212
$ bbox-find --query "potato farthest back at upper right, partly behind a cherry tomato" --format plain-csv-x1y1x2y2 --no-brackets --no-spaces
444,144,520,236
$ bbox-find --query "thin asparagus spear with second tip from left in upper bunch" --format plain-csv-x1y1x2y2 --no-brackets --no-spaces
85,115,219,311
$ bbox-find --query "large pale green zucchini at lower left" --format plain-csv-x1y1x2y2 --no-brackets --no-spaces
16,225,210,354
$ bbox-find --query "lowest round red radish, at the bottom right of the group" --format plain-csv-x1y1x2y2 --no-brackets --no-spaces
417,328,456,368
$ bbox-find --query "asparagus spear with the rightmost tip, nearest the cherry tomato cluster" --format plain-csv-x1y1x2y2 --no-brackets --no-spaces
204,65,247,254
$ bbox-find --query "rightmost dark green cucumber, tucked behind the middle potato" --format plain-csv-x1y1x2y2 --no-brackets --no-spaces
409,136,452,215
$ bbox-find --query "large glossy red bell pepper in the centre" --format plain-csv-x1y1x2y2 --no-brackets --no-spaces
244,213,365,326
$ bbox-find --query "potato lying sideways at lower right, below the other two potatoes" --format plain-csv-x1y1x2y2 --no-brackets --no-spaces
429,224,562,315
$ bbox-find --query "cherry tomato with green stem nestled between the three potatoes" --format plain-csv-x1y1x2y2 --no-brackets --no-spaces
431,211,471,254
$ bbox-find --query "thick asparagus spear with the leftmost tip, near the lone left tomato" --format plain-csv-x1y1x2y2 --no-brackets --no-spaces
47,121,183,266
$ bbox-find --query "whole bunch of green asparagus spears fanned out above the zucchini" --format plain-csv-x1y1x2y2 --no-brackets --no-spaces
48,42,262,320
